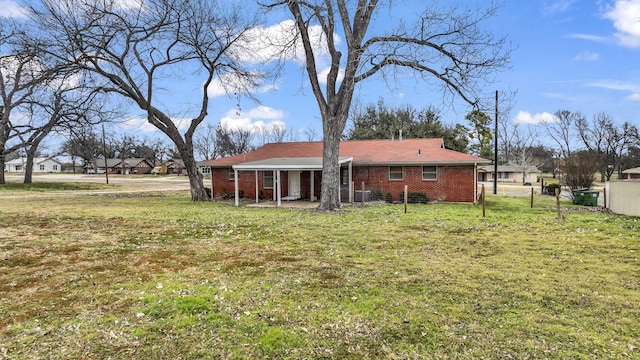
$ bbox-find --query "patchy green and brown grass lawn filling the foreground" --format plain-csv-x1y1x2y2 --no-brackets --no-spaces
0,190,640,359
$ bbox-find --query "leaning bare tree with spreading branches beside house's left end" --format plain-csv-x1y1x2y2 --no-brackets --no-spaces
32,0,260,201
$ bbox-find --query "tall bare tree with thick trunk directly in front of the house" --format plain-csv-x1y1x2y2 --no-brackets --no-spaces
266,0,510,210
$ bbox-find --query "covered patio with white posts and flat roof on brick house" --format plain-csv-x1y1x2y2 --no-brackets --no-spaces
232,157,353,207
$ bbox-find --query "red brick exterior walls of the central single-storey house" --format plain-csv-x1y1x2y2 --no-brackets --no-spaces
211,166,475,202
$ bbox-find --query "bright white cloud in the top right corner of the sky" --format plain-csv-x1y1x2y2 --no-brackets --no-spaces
605,0,640,47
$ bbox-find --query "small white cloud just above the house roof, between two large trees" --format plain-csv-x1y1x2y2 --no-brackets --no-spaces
220,105,286,133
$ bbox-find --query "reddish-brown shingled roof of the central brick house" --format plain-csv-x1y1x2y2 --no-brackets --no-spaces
202,138,490,167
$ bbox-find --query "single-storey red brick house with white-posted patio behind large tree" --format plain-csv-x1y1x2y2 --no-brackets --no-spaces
202,139,490,204
